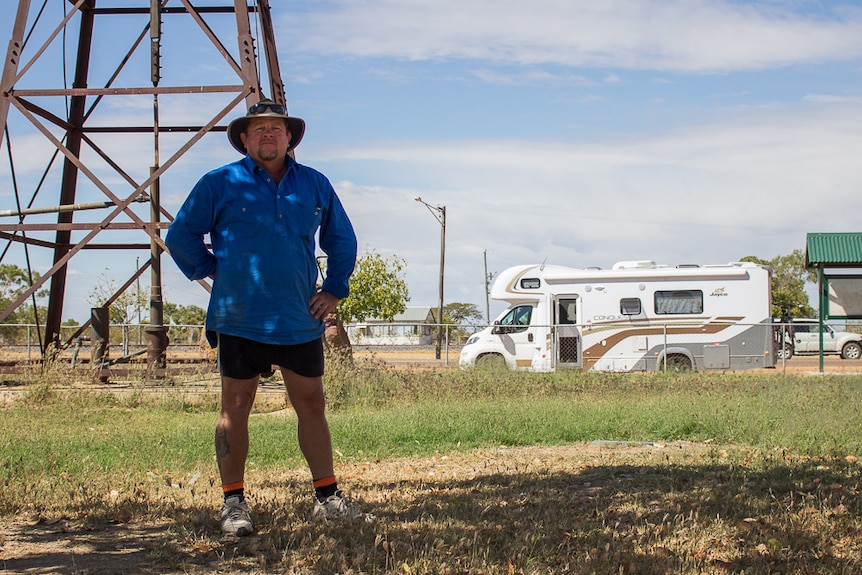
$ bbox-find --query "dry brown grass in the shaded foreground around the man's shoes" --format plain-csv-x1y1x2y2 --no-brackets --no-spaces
0,443,862,575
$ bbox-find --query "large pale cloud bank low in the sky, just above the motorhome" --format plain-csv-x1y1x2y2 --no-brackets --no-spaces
322,98,862,305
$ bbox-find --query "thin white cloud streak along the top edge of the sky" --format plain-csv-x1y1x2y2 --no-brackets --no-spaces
281,0,862,72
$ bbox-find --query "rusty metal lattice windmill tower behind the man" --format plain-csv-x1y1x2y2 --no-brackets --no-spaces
0,0,286,374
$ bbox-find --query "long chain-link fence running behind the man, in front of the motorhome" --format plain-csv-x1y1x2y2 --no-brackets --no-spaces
0,320,862,373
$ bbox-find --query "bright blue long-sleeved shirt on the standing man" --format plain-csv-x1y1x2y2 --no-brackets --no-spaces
165,156,356,346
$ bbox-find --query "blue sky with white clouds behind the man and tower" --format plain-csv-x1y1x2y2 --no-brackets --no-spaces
0,0,862,319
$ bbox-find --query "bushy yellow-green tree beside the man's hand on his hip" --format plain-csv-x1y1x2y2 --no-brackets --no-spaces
338,250,410,323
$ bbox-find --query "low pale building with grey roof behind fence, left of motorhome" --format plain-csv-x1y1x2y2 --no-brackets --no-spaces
344,307,437,345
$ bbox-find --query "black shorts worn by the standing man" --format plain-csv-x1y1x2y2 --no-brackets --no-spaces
217,333,323,379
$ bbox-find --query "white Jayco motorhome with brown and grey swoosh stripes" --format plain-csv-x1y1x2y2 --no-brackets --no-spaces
459,261,775,372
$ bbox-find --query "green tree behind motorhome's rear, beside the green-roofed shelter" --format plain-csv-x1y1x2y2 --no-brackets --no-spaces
740,250,817,318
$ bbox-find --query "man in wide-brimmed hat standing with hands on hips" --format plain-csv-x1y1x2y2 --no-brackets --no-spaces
165,100,356,536
